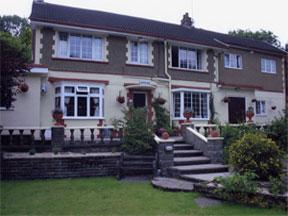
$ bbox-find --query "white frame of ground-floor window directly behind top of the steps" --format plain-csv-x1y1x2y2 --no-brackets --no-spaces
171,88,211,121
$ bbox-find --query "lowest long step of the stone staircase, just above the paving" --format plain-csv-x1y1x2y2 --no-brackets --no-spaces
168,164,228,177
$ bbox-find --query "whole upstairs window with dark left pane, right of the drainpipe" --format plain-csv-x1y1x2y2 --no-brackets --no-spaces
172,46,203,70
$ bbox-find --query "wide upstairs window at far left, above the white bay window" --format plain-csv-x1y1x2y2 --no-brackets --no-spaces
58,32,104,61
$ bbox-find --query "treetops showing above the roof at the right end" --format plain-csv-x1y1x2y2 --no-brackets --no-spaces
228,29,281,47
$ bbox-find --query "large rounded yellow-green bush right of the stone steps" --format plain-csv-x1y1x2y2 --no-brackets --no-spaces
229,133,283,180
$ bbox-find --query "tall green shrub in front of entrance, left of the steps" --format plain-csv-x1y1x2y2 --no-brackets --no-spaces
122,108,153,154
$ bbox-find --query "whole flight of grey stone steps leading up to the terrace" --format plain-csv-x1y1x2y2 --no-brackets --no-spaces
168,140,229,182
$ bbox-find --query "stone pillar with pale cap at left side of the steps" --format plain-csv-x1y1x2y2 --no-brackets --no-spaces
157,138,174,176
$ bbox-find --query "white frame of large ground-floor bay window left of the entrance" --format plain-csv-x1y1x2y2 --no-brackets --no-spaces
54,82,105,119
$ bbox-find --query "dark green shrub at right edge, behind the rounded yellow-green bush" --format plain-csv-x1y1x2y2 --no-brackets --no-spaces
266,110,288,152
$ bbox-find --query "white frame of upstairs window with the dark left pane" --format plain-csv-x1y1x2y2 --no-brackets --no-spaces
170,45,206,72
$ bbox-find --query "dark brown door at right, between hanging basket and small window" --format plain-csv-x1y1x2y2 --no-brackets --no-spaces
228,97,246,124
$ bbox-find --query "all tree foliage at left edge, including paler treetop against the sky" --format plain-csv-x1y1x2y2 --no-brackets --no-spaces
0,15,32,109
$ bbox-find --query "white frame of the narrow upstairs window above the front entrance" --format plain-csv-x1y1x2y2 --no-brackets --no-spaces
128,40,151,66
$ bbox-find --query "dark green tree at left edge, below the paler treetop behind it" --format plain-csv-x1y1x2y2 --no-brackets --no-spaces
0,32,29,109
